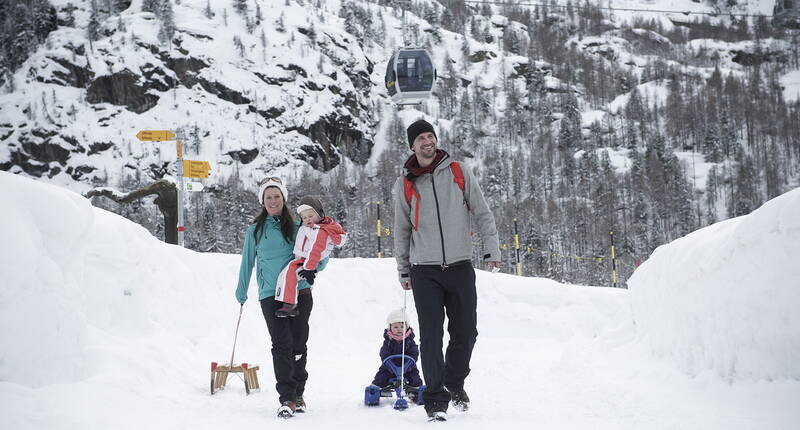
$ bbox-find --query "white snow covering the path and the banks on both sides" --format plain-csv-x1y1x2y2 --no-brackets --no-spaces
0,172,800,430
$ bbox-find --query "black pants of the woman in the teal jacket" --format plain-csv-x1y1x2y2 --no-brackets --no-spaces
261,290,314,403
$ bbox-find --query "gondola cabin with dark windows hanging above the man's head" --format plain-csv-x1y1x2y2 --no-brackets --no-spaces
386,48,436,105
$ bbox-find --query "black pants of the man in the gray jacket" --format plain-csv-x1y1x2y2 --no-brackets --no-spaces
411,262,478,410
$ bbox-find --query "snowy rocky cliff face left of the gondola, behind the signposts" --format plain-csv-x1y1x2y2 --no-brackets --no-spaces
0,2,380,187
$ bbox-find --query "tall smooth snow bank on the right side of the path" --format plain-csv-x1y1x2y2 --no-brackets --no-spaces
628,189,800,380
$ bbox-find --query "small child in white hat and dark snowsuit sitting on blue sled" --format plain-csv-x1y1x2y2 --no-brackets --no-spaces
372,309,422,403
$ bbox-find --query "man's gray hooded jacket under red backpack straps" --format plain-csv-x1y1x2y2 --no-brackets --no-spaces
392,155,500,281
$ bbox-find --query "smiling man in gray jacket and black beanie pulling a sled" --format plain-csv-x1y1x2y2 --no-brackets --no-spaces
393,120,500,421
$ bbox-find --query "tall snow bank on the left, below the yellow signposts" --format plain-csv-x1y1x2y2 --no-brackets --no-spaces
0,172,244,388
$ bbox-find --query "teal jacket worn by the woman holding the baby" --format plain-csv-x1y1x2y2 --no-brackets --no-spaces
236,216,328,303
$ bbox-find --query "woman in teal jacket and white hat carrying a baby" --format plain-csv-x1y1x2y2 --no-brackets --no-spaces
236,177,328,418
